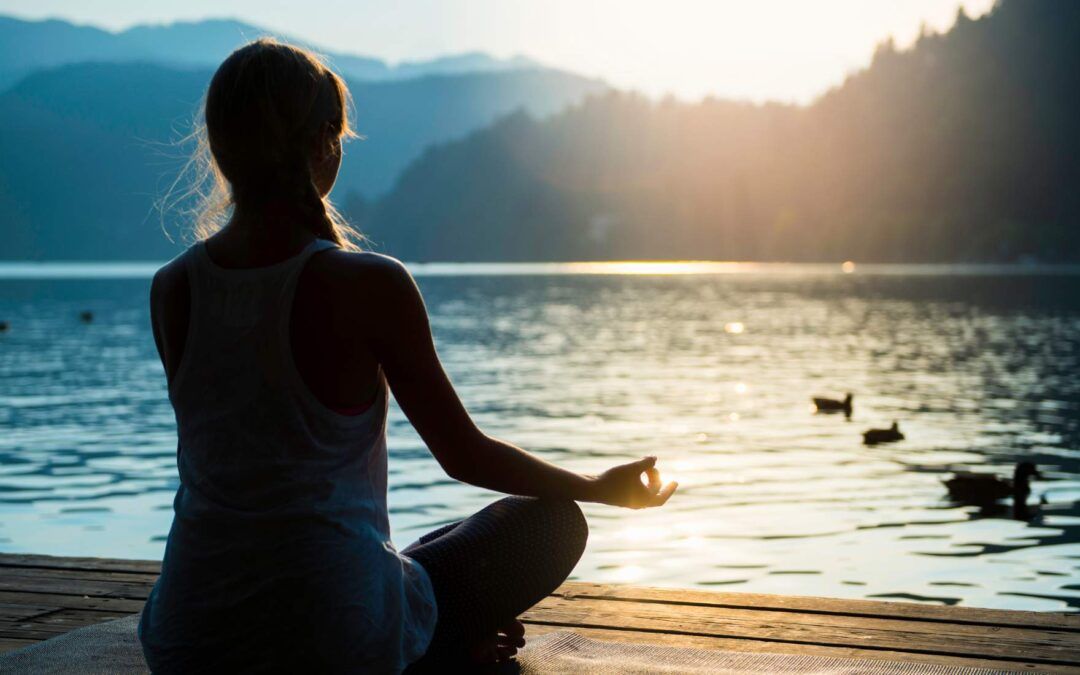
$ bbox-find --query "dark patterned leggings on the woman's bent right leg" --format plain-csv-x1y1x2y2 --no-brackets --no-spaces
402,497,589,671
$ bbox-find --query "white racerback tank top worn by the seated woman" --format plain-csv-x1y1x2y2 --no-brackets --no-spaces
139,240,435,672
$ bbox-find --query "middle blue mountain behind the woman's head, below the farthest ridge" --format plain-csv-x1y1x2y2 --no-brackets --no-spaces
0,63,606,259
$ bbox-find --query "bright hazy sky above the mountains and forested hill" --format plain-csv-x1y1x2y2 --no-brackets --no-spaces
0,0,994,102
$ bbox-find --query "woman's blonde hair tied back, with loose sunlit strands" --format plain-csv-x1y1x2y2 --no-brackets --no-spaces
163,38,363,251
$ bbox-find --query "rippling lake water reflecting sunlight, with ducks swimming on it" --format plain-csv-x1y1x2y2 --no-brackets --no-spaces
0,264,1080,610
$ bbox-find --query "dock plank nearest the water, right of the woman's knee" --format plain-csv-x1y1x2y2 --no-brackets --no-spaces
553,581,1080,632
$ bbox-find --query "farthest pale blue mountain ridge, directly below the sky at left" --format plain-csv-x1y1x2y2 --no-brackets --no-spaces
0,16,542,90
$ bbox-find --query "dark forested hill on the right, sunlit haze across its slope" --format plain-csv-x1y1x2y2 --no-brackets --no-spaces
365,0,1080,261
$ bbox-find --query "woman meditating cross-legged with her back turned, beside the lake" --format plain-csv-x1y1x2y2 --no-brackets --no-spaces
139,40,675,673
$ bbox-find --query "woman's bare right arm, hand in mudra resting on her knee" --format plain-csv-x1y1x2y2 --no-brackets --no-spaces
361,254,677,509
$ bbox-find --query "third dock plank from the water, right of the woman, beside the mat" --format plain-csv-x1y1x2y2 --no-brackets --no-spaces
525,621,1077,674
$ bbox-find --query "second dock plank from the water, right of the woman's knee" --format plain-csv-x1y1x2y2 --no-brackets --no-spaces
523,596,1080,665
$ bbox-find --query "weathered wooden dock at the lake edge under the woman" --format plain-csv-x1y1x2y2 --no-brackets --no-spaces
0,554,1080,673
